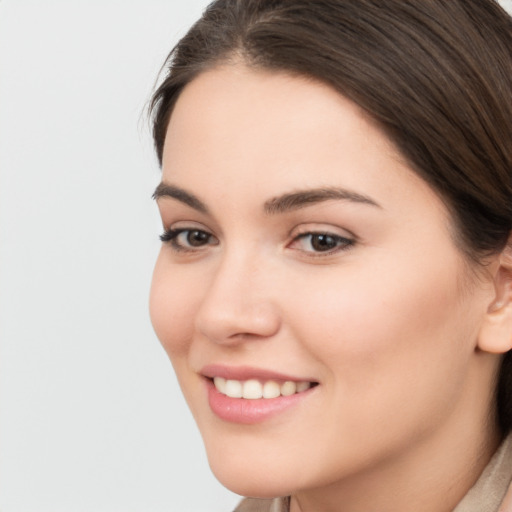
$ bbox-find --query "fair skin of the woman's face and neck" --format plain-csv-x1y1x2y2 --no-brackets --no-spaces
151,64,510,512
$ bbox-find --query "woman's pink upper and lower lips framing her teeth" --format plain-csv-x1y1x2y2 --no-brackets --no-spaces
201,365,316,425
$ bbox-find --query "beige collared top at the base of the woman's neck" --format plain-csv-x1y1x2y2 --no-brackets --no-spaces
233,434,512,512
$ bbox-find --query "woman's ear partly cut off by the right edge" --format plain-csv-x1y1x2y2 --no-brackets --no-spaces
478,240,512,354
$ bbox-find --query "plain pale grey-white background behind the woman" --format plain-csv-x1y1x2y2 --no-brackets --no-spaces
0,0,512,512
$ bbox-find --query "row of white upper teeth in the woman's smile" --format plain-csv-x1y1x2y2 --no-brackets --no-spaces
213,377,311,400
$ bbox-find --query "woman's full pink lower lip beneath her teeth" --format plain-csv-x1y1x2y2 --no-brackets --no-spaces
206,379,315,425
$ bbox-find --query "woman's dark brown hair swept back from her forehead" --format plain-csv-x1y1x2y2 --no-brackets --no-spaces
150,0,512,432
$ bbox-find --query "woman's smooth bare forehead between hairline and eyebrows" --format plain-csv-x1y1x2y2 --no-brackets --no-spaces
163,65,444,219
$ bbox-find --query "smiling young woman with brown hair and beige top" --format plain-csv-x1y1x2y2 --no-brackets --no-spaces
151,0,512,512
